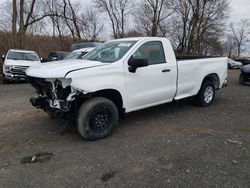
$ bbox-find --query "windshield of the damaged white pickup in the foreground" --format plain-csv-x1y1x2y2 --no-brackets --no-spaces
83,41,137,63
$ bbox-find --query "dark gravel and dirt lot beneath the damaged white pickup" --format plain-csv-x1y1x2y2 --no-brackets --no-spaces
0,70,250,188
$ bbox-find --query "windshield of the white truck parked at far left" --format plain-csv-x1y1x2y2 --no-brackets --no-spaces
7,51,39,61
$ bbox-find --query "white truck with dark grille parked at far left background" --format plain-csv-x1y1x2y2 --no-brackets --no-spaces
2,49,41,84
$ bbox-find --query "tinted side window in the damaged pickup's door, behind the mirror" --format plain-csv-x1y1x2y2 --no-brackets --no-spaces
133,41,166,65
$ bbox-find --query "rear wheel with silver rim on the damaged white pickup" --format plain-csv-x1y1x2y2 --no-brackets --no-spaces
196,81,215,107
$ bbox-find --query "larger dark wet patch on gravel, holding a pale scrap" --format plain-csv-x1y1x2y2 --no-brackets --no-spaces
21,152,54,164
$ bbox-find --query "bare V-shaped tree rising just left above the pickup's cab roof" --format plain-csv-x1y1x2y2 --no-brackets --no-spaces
94,0,131,38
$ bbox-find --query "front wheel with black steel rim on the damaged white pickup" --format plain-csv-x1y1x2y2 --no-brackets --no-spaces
77,97,119,140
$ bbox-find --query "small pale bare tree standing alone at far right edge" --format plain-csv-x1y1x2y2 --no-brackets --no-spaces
230,19,250,57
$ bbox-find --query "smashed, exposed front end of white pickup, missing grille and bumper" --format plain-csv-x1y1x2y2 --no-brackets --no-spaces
28,77,81,117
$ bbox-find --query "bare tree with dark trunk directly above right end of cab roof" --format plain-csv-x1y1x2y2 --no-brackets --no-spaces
134,0,173,36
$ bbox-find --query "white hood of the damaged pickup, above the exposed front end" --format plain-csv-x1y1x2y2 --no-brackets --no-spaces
26,59,107,78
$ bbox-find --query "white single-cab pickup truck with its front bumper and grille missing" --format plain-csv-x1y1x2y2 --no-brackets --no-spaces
26,37,227,140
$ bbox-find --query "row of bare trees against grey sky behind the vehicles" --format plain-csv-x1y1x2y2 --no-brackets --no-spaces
0,0,250,57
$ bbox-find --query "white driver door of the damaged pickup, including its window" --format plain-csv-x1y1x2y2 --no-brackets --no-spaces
125,41,177,111
